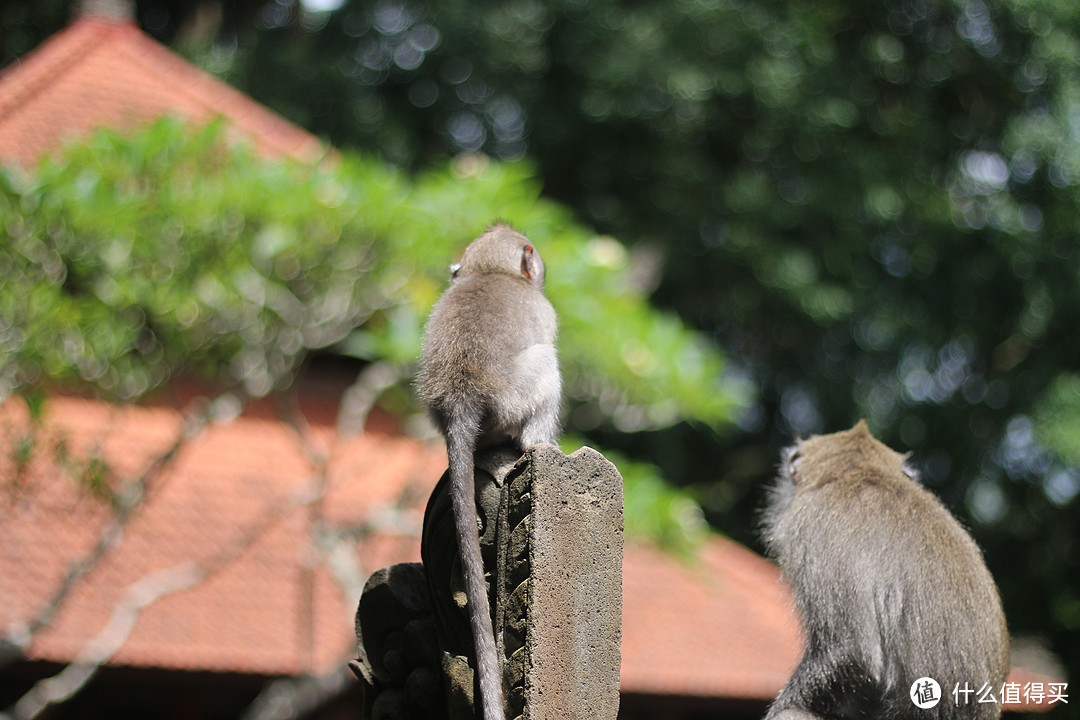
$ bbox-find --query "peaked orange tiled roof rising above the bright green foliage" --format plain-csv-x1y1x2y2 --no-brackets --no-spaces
0,16,325,165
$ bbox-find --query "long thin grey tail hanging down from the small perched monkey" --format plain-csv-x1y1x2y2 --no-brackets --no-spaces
446,416,505,720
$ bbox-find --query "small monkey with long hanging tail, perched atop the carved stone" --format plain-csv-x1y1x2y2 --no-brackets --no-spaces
417,225,561,720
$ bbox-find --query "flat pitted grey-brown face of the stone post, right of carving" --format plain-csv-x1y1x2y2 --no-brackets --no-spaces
524,446,623,720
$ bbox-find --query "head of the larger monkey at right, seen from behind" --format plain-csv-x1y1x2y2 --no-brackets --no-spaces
780,420,915,489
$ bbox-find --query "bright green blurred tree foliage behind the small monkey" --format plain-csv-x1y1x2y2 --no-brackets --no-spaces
0,119,738,540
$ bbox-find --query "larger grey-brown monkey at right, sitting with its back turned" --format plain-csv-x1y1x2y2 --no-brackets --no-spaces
764,421,1009,720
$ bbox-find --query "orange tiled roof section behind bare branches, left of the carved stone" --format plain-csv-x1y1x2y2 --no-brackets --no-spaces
0,397,446,675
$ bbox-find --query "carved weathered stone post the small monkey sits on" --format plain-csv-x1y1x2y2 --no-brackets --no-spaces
353,446,622,720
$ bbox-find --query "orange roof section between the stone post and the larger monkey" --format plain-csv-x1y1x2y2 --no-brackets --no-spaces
622,536,801,698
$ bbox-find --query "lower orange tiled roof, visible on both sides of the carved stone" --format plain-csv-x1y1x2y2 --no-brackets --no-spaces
0,397,798,698
